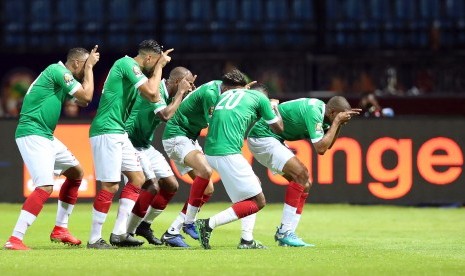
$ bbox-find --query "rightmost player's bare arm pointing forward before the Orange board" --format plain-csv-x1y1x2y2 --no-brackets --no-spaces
313,109,359,155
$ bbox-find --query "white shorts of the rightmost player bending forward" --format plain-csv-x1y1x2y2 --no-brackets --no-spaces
247,137,295,174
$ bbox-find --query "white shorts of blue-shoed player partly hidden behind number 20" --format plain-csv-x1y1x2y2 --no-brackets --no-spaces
162,136,203,175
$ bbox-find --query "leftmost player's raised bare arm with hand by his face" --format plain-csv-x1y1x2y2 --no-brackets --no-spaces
73,45,100,107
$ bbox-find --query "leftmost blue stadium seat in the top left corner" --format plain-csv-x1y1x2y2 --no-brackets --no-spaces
2,0,27,47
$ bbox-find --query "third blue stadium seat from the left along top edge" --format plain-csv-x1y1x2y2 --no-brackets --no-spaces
55,0,79,47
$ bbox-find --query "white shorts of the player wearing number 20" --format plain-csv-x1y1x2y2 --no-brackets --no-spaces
206,154,262,203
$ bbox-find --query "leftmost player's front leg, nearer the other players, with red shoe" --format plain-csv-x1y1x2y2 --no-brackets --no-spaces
50,137,84,245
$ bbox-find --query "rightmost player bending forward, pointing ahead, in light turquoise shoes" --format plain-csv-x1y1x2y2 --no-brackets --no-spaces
247,96,361,247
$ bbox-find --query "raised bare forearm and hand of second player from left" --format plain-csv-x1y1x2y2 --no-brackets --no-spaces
138,49,174,103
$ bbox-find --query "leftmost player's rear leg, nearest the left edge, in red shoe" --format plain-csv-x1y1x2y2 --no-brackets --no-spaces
4,135,55,250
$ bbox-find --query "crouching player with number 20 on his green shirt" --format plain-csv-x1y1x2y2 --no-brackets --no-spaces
195,85,283,249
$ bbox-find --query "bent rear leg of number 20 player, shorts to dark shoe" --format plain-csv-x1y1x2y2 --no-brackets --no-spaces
195,154,266,249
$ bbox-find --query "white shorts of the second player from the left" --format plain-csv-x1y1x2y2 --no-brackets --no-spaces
90,133,142,182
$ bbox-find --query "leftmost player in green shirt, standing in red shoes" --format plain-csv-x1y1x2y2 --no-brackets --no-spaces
4,46,100,250
